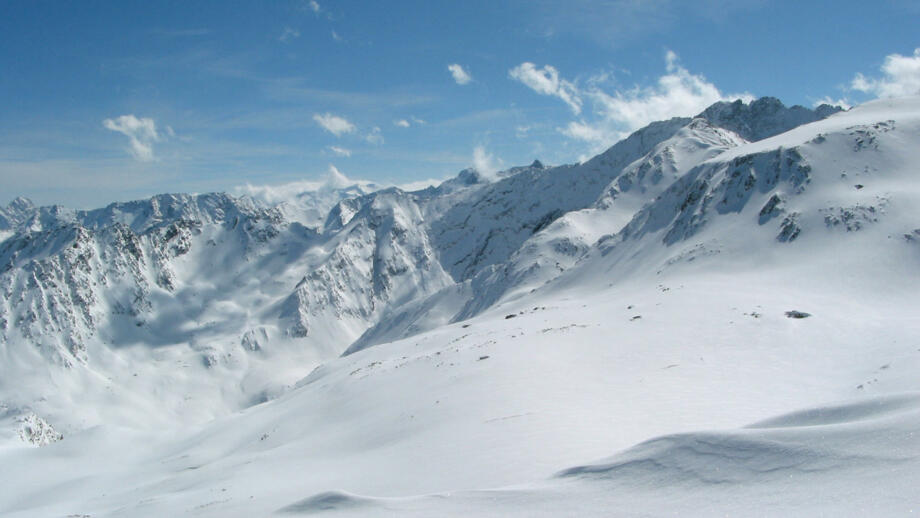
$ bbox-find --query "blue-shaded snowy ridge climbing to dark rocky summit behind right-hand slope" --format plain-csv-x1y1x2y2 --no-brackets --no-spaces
349,97,840,352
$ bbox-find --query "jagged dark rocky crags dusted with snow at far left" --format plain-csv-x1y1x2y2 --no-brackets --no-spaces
0,194,284,366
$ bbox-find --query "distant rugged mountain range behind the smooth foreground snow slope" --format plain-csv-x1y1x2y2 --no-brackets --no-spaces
0,98,856,430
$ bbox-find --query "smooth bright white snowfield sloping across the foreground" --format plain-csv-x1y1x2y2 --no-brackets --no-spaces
7,265,920,516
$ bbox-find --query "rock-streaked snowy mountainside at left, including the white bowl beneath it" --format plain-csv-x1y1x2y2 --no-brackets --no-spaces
0,188,460,432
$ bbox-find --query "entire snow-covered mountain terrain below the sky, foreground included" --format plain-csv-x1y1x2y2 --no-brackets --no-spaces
0,98,920,518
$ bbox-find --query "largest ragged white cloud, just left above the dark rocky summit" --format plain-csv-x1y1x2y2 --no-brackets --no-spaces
510,51,754,152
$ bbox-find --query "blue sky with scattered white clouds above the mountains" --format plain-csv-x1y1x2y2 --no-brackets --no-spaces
0,0,920,208
